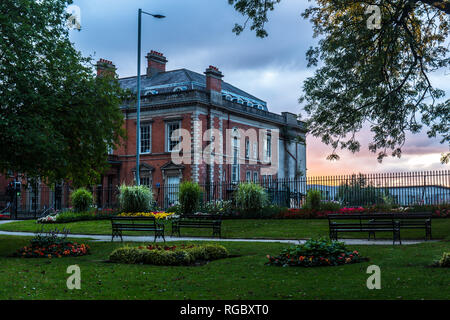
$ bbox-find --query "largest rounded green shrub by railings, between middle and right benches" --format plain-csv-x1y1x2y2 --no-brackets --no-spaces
235,182,268,217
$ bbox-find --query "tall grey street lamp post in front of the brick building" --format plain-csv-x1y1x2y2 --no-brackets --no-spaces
136,9,165,185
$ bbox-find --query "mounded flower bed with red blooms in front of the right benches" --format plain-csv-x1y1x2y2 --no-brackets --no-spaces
266,239,368,267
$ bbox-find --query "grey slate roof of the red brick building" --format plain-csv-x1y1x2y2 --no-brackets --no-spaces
119,69,267,111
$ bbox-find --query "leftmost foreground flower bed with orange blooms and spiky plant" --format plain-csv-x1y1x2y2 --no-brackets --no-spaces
14,232,90,258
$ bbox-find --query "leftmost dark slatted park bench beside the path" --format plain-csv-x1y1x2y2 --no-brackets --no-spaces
111,217,166,242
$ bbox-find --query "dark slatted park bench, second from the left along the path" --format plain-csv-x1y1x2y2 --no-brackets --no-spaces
172,215,222,238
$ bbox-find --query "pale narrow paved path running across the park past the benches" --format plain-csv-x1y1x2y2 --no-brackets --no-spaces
0,221,435,245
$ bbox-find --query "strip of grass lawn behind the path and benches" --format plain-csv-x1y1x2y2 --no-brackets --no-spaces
0,219,450,240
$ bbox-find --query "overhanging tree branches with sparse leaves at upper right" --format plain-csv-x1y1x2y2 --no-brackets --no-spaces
229,0,450,163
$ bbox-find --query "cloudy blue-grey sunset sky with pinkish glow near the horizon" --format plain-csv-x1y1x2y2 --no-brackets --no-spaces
70,0,450,176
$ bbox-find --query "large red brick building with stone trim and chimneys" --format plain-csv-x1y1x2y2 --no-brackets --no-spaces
0,51,306,210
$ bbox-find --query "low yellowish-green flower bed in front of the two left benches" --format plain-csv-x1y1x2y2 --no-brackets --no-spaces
109,244,229,266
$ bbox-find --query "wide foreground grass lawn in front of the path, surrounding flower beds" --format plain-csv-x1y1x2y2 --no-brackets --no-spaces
0,236,450,299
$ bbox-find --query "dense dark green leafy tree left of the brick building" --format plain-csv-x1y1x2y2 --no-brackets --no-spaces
0,0,125,186
